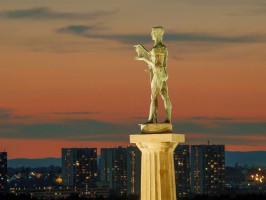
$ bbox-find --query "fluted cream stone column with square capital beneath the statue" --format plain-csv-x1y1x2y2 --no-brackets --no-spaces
130,124,185,200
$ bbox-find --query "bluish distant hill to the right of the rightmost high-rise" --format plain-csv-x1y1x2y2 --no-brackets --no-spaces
225,151,266,167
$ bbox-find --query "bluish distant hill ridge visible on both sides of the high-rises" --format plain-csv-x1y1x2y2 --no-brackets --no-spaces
7,151,266,168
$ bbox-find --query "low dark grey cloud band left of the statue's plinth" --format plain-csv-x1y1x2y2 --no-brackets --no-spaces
0,119,138,141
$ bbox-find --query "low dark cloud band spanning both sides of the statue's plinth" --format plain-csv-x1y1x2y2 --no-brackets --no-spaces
0,109,266,144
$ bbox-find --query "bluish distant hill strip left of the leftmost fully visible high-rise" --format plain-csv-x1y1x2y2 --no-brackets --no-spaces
7,158,62,168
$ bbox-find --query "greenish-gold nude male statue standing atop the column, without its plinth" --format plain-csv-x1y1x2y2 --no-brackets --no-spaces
135,27,172,124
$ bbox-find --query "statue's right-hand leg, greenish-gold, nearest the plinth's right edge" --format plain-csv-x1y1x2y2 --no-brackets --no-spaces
160,81,172,123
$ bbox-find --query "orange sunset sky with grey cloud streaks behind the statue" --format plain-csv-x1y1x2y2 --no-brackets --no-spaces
0,0,266,158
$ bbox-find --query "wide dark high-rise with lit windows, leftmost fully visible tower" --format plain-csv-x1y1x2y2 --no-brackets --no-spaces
62,148,97,189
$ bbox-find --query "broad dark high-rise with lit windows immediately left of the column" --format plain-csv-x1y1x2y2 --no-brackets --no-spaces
100,147,140,196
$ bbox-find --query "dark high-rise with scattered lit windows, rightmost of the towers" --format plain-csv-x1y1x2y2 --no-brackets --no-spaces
191,145,225,195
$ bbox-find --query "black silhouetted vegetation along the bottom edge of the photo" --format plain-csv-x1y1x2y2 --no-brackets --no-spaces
0,194,266,200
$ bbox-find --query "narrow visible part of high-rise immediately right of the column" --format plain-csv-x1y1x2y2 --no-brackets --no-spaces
174,145,190,199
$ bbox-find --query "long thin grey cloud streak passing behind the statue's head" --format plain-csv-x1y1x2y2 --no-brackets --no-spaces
57,25,266,44
